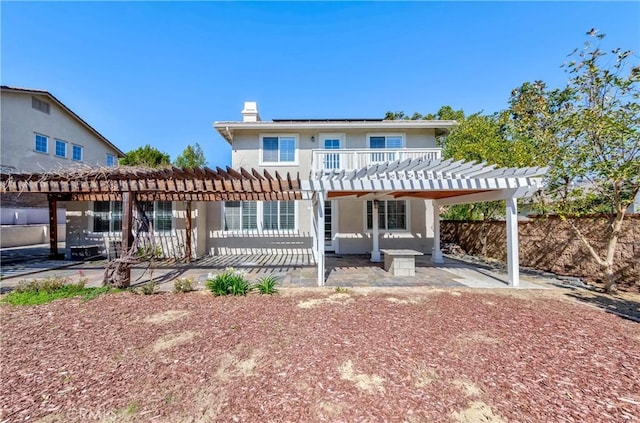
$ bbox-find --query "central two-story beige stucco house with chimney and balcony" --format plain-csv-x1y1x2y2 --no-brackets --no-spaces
207,102,456,260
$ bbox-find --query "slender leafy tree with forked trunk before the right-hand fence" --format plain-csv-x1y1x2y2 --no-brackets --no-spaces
548,30,640,292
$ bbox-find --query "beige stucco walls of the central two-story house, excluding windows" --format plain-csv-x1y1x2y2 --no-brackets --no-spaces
200,129,436,255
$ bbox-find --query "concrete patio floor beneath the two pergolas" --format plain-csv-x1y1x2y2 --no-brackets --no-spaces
0,248,557,292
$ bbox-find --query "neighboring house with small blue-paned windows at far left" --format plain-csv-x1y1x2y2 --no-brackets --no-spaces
0,85,124,247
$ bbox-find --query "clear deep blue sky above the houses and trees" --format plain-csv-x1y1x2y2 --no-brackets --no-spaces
0,1,640,166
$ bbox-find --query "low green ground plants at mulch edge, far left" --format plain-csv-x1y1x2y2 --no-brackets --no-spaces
2,277,111,305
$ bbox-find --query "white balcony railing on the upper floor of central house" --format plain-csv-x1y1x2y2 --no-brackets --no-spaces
311,148,441,173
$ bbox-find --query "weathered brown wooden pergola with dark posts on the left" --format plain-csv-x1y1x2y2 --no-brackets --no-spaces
0,166,303,282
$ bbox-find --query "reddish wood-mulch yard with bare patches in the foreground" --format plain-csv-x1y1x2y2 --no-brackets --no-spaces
0,288,640,423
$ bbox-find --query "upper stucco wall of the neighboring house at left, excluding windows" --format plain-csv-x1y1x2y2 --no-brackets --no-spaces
0,91,117,171
